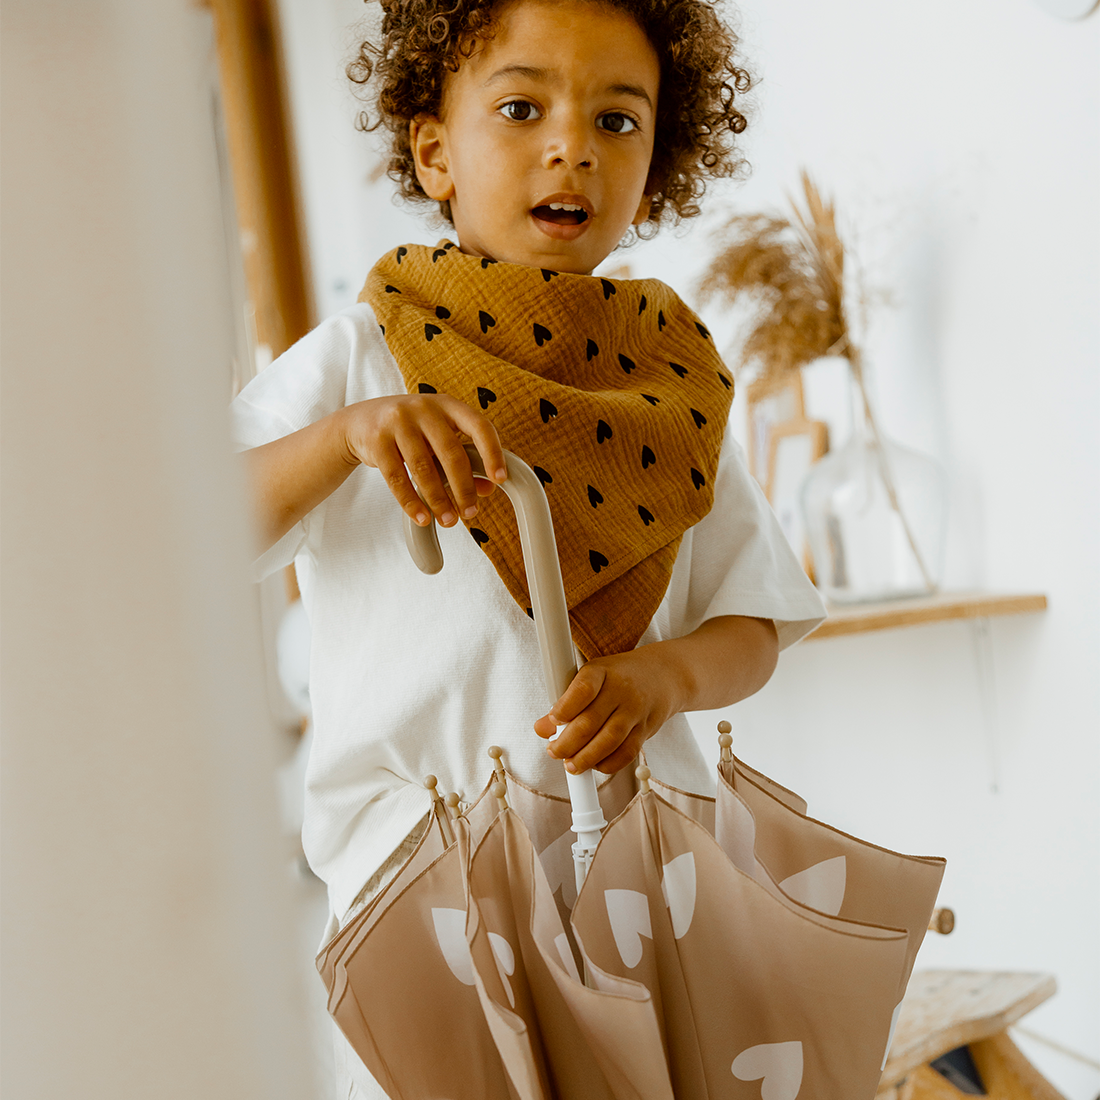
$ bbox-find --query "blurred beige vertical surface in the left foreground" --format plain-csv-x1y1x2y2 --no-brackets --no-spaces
0,8,309,1100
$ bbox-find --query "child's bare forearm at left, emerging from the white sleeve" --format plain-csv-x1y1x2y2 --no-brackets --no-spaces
244,409,359,550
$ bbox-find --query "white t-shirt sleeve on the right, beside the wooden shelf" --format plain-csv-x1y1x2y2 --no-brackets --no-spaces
672,429,825,649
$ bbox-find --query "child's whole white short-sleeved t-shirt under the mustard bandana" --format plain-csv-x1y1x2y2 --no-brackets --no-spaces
232,304,824,914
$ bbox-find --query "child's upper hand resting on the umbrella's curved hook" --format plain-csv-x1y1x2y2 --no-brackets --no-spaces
341,394,507,527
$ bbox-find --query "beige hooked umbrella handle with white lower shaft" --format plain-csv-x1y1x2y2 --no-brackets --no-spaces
403,443,607,887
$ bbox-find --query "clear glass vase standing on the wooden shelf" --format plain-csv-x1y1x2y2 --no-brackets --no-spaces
801,408,947,604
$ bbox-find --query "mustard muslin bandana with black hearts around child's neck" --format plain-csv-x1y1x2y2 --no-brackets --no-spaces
360,241,733,660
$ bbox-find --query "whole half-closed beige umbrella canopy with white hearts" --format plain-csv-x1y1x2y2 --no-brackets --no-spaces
318,454,944,1100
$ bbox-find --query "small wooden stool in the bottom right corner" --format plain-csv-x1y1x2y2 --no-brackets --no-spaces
876,970,1065,1100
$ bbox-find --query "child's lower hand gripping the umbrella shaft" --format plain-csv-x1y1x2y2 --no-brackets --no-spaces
535,642,683,774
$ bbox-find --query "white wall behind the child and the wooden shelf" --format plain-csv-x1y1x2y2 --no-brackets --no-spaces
282,0,1100,1100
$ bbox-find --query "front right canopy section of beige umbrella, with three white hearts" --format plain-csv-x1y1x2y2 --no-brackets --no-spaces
572,772,935,1100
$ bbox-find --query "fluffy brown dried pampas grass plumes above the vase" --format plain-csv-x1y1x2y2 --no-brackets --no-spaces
700,171,858,394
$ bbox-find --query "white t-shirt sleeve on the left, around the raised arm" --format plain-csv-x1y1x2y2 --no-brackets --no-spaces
230,304,399,580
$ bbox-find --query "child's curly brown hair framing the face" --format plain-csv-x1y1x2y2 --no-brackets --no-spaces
347,0,752,229
